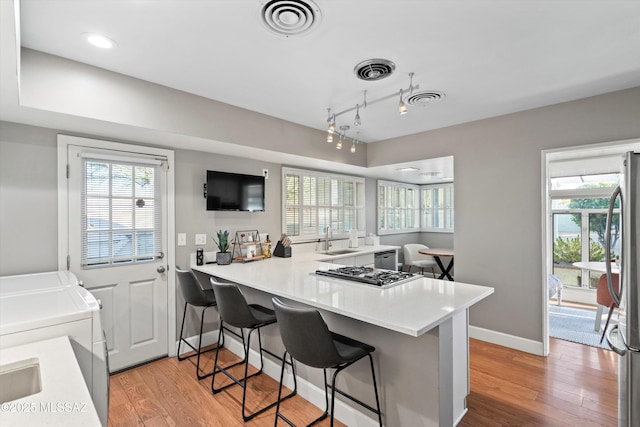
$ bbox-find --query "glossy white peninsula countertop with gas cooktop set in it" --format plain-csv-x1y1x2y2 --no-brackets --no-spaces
191,245,494,336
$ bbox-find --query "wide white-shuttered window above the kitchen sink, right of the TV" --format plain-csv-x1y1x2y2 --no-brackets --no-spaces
282,168,365,242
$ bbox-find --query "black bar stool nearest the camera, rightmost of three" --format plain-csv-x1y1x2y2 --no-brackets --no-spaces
273,298,382,427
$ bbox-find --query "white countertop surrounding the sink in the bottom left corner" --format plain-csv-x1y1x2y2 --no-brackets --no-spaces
0,337,101,426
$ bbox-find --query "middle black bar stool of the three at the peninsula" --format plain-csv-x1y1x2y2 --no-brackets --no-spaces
210,277,297,421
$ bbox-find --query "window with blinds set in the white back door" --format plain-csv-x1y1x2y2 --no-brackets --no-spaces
81,157,162,268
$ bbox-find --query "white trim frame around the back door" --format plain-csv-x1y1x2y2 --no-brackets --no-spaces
57,134,178,356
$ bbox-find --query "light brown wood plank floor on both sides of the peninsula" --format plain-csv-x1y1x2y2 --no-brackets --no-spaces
109,339,617,427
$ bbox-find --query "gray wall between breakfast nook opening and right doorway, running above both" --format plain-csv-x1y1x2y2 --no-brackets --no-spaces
367,88,640,342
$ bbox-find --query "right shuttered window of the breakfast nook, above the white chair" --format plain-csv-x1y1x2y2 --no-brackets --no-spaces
420,184,454,231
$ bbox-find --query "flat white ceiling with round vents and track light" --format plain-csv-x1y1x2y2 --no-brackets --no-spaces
0,0,640,181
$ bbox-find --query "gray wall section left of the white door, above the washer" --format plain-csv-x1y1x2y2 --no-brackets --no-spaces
0,122,58,276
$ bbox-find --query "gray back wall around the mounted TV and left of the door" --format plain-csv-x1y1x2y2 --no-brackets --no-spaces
0,122,452,342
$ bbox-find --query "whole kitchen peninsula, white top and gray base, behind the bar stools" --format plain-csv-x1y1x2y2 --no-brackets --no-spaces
191,244,494,427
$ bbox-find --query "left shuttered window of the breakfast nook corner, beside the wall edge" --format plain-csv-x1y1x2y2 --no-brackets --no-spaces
378,180,420,234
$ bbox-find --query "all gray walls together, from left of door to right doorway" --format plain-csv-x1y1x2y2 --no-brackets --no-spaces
0,88,640,348
